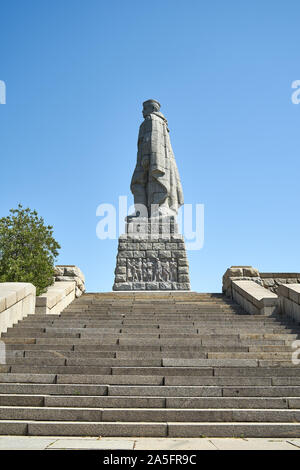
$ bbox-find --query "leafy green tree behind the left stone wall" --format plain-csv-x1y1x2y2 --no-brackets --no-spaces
0,204,60,295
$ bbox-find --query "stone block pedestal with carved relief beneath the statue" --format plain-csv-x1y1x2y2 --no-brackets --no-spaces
113,218,190,291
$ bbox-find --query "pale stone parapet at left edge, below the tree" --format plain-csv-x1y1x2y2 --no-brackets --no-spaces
0,282,36,333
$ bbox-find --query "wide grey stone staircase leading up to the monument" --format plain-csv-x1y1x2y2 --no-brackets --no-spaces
0,292,300,437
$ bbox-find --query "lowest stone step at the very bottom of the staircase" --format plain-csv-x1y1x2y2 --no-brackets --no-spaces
0,420,300,438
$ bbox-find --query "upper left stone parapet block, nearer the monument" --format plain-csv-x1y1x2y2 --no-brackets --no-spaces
35,281,76,315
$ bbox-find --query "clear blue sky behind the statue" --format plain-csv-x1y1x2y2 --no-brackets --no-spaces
0,0,300,292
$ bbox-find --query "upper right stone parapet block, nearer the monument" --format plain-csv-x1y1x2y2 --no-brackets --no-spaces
231,280,279,315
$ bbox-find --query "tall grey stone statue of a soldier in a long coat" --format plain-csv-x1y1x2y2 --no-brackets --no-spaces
130,100,183,217
